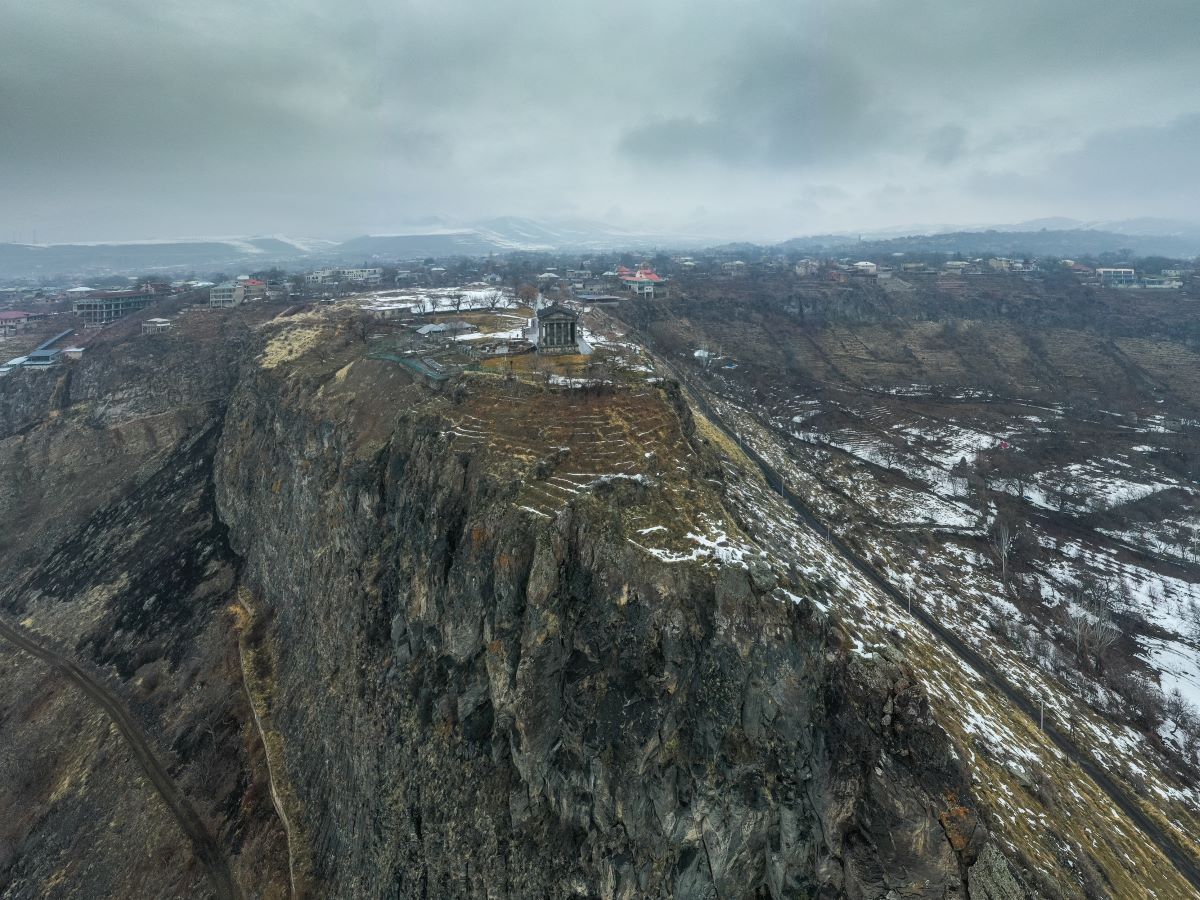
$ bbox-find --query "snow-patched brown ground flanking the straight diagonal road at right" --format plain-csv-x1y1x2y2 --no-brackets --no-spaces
691,376,1200,895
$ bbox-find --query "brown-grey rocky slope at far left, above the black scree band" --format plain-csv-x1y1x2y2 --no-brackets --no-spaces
0,313,254,572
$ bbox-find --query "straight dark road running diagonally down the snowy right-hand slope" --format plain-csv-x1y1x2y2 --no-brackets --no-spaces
670,370,1200,894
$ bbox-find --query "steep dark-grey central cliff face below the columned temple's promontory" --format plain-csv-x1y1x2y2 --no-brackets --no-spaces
216,336,1003,898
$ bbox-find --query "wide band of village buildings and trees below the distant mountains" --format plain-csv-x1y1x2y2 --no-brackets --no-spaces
0,251,1200,374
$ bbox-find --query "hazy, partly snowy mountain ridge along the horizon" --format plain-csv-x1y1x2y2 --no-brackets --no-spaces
0,216,1200,280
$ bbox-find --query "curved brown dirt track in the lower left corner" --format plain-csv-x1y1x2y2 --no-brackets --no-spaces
0,619,241,900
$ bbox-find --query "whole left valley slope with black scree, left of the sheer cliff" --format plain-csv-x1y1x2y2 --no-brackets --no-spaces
0,309,287,899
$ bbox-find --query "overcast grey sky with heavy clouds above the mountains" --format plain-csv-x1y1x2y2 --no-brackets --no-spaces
0,0,1200,241
